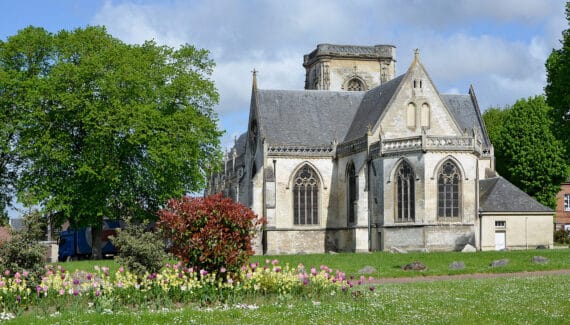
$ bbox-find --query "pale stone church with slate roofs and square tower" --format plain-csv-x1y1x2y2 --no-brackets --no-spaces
206,44,553,254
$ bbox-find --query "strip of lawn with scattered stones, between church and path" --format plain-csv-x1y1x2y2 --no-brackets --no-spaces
57,249,570,278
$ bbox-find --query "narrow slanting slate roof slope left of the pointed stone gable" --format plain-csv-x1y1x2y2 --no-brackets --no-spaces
344,74,405,142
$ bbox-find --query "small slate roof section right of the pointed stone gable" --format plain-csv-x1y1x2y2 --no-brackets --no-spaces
441,94,491,148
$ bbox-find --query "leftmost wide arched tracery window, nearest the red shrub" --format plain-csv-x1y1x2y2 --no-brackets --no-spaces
293,164,320,225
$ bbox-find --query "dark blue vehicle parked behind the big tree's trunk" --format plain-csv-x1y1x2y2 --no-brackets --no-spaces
58,220,122,262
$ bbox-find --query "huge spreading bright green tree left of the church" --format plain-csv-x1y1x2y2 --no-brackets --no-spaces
0,27,221,239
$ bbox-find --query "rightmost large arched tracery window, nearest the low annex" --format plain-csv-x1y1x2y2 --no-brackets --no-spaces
437,160,461,219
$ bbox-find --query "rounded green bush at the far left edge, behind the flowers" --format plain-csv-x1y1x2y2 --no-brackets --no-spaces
0,232,46,281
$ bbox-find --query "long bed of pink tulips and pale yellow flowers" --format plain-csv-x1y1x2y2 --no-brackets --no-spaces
0,260,374,318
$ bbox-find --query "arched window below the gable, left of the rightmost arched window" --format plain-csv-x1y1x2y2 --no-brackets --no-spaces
396,160,415,222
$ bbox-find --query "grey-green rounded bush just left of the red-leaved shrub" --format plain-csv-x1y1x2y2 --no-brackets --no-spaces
110,223,166,275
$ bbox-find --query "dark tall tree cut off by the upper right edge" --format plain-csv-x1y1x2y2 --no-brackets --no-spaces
544,2,570,162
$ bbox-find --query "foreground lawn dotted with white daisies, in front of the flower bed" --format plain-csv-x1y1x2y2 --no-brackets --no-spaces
9,275,570,324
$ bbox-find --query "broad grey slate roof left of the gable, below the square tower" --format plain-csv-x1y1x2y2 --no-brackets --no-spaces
257,89,365,146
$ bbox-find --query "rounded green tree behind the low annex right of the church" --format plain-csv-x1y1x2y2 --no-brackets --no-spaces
483,96,568,207
